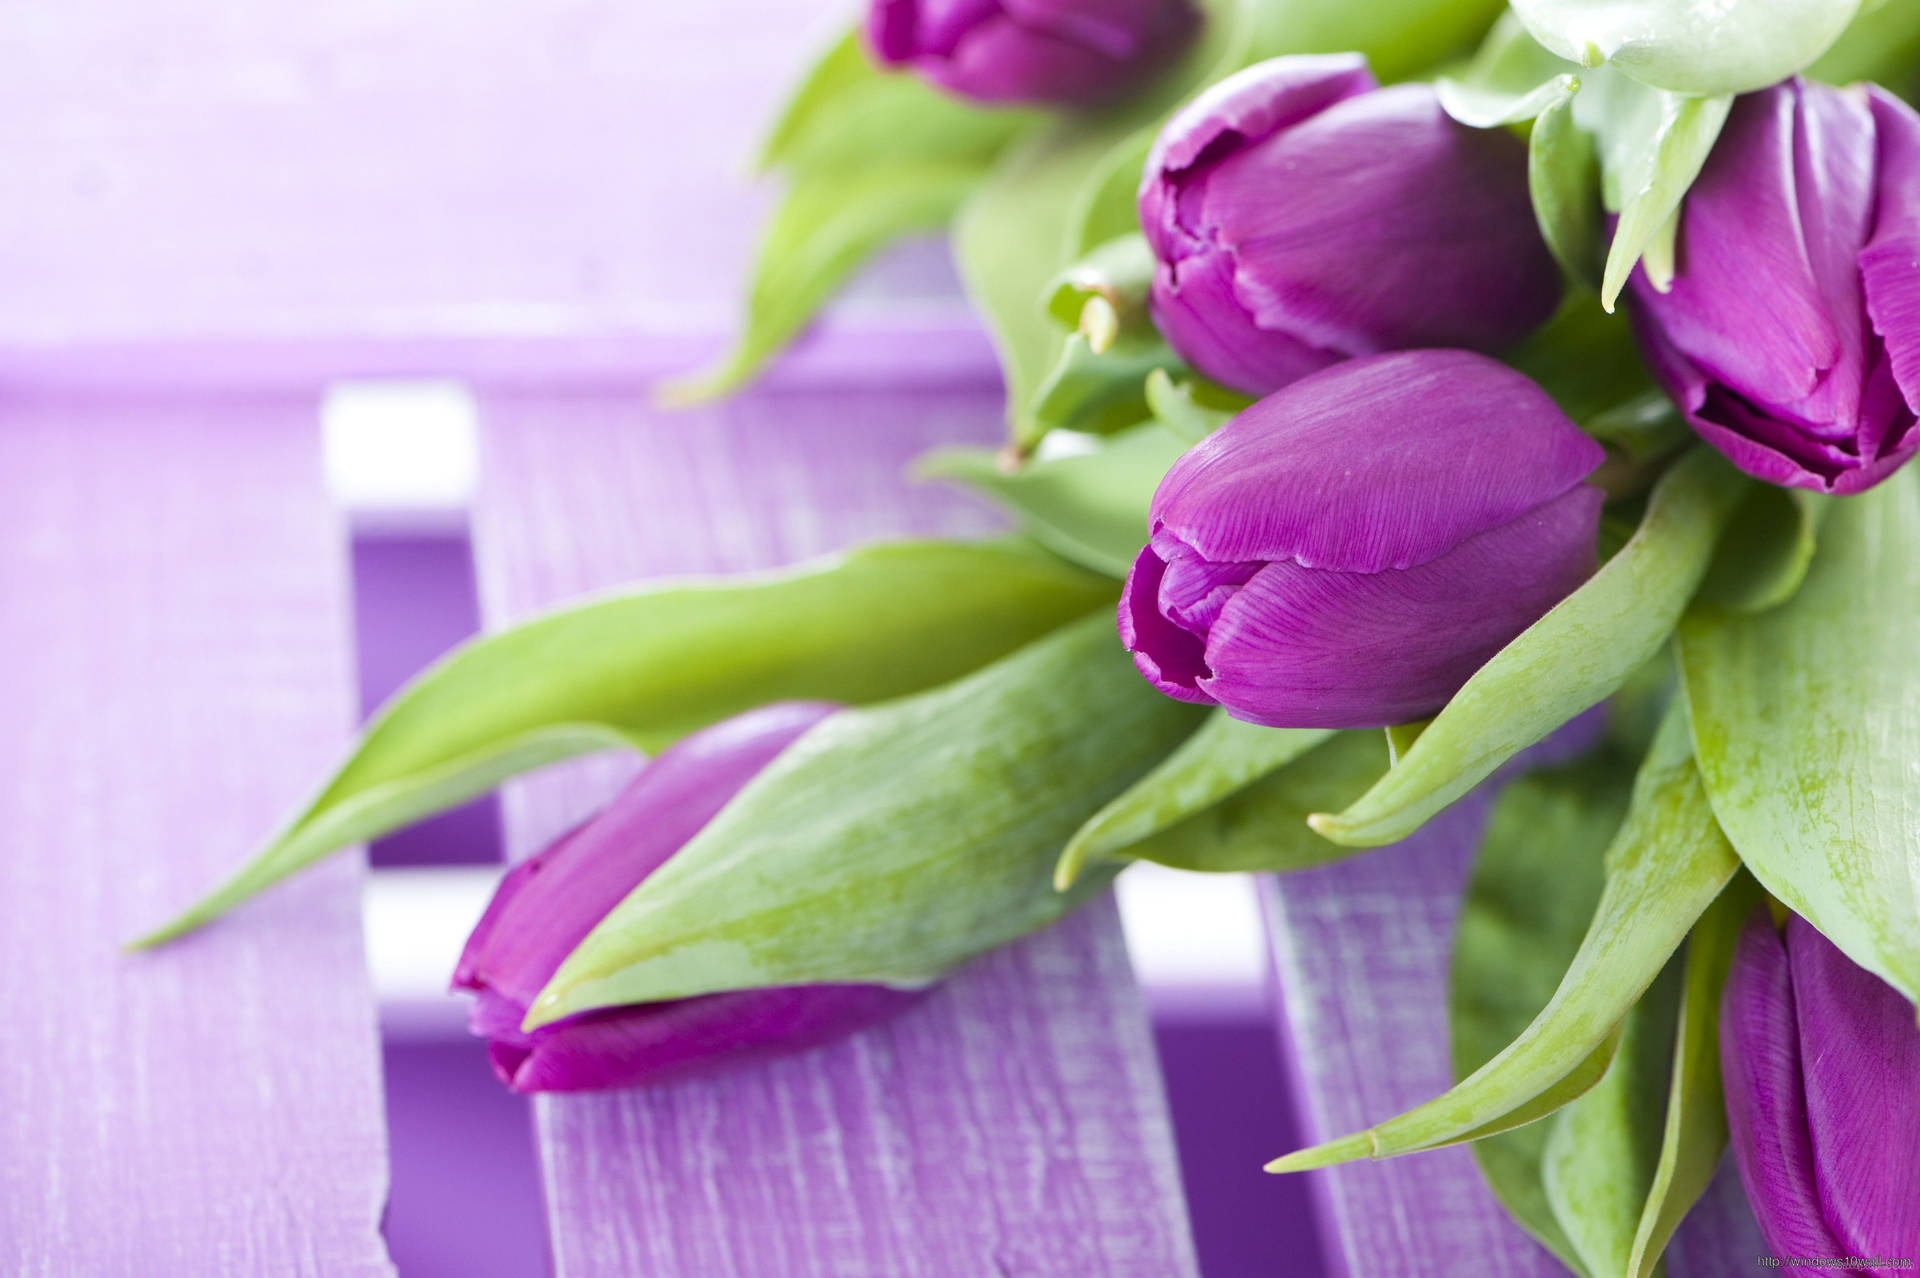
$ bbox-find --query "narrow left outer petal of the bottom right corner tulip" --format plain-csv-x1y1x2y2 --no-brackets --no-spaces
1720,906,1847,1257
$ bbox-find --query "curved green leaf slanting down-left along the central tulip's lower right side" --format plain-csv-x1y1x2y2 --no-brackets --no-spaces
1313,447,1745,846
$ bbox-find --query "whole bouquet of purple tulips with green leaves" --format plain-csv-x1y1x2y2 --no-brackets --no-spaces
142,0,1920,1276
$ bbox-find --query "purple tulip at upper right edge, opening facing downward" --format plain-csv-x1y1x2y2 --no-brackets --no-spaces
1632,81,1920,493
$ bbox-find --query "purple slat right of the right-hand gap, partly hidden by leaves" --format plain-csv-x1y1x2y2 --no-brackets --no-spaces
1263,791,1764,1278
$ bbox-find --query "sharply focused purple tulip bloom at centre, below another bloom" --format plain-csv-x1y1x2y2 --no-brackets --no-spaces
1119,351,1605,727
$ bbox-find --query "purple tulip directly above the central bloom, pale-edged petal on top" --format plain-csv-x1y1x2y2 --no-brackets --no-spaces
1140,54,1561,395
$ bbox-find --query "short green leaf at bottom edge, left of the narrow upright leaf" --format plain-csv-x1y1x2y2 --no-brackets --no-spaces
1540,963,1680,1276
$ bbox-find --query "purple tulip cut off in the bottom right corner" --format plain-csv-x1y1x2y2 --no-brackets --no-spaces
1720,908,1920,1274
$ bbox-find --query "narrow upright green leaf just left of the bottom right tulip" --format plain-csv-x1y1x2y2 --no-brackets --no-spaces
1617,875,1761,1278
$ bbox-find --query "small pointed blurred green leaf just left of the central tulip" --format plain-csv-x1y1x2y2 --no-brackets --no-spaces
914,426,1185,578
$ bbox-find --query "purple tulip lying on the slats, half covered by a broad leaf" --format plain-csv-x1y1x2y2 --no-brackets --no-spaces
453,702,916,1092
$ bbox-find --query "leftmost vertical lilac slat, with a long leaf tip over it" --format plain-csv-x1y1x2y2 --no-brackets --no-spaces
0,397,392,1278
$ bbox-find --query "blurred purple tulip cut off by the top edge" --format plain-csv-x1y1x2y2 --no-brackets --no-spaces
866,0,1200,106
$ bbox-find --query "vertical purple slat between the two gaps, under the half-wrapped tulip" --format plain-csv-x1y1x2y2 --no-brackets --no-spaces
476,388,1194,1278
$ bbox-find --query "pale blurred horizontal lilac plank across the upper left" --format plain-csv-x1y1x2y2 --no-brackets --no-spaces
0,0,954,347
